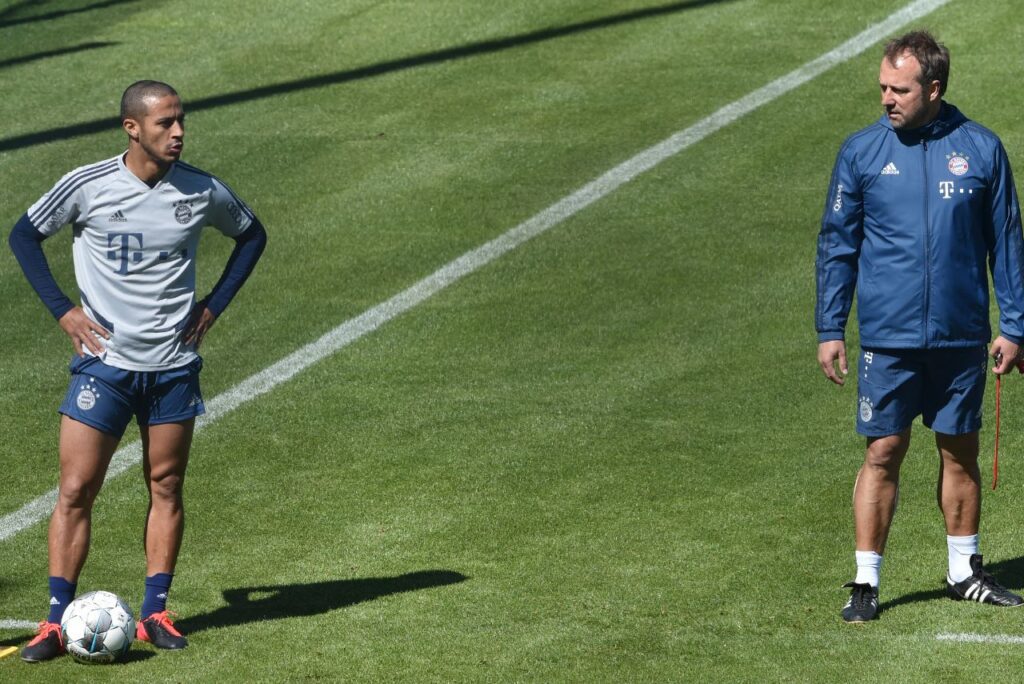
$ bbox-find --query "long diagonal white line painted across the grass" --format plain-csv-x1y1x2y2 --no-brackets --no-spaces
0,0,951,542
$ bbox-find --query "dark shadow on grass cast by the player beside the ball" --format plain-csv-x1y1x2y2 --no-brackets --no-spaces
176,570,469,634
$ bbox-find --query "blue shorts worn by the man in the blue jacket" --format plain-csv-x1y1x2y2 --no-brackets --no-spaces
857,345,988,437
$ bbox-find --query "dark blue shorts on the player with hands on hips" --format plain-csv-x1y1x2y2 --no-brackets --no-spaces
58,356,206,437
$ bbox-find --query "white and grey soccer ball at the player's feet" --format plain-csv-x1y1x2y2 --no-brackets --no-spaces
60,592,135,662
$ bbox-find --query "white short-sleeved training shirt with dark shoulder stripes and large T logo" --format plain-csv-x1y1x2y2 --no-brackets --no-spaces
29,155,254,371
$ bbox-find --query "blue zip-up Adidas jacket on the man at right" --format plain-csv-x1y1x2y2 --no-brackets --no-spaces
815,102,1024,349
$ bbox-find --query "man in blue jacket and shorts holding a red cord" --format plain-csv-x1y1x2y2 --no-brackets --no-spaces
815,32,1024,623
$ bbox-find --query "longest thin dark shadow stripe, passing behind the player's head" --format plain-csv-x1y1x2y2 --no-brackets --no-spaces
0,0,734,152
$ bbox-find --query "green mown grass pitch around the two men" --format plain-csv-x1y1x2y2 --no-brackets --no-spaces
0,0,1024,683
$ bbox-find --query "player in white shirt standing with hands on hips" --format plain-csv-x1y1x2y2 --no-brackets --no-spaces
9,81,266,662
